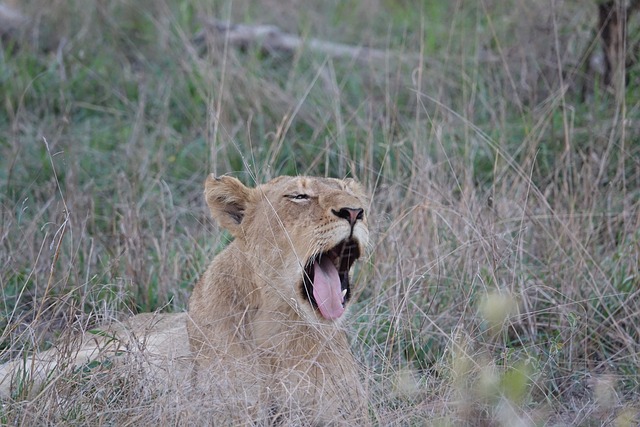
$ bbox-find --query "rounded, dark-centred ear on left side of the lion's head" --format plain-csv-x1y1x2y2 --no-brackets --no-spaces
204,175,252,237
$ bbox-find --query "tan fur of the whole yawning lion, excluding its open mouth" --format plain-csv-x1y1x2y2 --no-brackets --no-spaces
0,176,368,425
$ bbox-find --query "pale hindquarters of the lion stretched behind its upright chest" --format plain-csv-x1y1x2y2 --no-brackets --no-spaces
0,313,192,399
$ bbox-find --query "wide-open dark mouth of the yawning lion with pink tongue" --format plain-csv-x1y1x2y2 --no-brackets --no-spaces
302,239,360,320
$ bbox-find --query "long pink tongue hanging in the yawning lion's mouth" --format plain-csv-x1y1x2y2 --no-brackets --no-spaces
313,257,344,320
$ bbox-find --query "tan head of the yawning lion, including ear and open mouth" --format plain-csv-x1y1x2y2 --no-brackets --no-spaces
205,176,369,321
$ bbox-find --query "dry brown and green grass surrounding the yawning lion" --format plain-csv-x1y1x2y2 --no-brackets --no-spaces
0,0,640,426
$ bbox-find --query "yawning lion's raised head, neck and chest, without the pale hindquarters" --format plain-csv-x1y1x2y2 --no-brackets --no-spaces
187,176,369,425
